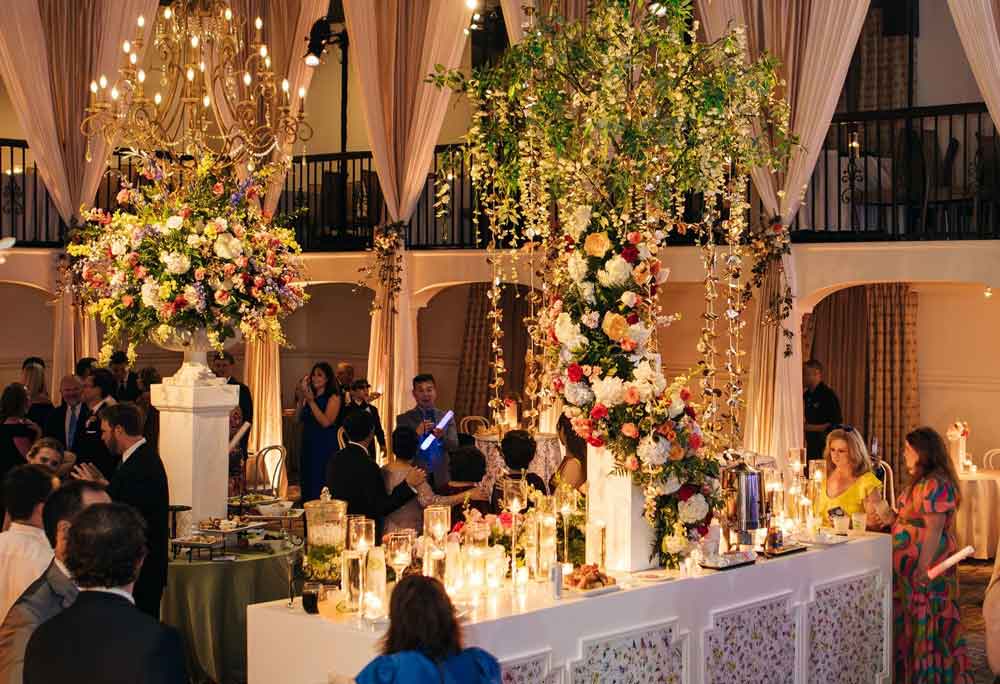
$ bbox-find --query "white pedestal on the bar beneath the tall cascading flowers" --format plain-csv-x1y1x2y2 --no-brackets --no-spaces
587,447,656,572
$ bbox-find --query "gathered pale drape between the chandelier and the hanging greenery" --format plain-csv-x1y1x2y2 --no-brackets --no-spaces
344,0,472,440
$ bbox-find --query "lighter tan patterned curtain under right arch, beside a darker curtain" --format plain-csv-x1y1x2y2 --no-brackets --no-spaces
865,283,920,483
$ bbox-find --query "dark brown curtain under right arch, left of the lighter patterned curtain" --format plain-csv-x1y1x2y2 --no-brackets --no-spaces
806,287,868,430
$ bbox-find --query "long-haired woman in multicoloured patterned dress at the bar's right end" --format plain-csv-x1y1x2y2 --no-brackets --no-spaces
869,427,973,684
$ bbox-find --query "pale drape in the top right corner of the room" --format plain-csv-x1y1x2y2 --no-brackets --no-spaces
948,0,1000,131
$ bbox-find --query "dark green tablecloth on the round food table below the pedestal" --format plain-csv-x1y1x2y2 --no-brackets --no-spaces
161,552,288,684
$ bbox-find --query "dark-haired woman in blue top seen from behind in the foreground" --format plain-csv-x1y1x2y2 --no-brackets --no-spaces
354,575,501,684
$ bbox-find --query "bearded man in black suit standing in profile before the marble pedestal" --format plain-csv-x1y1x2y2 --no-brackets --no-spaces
73,402,170,619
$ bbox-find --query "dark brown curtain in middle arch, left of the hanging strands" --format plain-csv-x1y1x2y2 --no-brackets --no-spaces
455,283,491,420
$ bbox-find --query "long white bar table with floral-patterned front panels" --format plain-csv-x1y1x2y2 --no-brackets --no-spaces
247,534,892,684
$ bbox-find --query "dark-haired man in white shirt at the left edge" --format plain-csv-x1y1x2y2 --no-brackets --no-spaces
0,465,57,621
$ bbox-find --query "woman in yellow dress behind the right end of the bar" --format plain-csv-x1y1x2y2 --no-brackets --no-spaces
815,426,882,521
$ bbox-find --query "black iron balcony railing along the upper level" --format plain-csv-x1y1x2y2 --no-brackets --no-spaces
0,102,1000,251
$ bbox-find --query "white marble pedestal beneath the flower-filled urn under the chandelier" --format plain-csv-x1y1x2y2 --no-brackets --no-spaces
151,352,239,529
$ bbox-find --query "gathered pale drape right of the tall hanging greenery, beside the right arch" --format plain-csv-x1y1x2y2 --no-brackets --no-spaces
697,0,869,463
